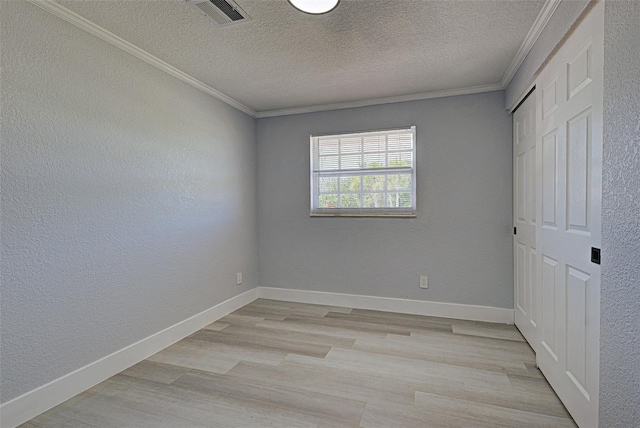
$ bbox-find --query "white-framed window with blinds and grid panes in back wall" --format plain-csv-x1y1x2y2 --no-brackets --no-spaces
311,126,416,217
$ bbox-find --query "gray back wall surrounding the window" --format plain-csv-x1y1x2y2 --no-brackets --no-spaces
257,91,513,308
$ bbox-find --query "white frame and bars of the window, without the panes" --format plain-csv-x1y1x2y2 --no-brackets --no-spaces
309,125,417,218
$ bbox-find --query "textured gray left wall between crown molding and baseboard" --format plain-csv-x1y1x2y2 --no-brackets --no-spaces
0,1,257,402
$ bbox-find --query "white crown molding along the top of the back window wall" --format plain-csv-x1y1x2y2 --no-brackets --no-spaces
256,83,504,119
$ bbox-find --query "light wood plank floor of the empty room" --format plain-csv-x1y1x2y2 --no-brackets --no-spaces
22,300,575,428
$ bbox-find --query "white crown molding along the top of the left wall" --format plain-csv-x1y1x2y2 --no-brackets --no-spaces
27,0,256,117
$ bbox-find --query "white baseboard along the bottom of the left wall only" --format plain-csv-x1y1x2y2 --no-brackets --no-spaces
0,288,258,428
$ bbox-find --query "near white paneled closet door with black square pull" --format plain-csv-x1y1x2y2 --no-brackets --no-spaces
536,2,604,428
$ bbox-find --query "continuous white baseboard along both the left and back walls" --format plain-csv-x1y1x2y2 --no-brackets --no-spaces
0,287,514,428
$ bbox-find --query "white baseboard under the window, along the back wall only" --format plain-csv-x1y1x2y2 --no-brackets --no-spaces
258,287,515,324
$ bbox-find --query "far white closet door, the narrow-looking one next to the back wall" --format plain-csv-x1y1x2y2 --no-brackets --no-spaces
513,93,538,351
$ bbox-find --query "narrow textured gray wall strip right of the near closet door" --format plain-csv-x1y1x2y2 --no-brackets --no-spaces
600,0,640,428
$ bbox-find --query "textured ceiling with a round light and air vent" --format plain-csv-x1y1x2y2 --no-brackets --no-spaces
59,0,544,112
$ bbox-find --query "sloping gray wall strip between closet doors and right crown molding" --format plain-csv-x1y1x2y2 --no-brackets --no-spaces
505,0,589,108
